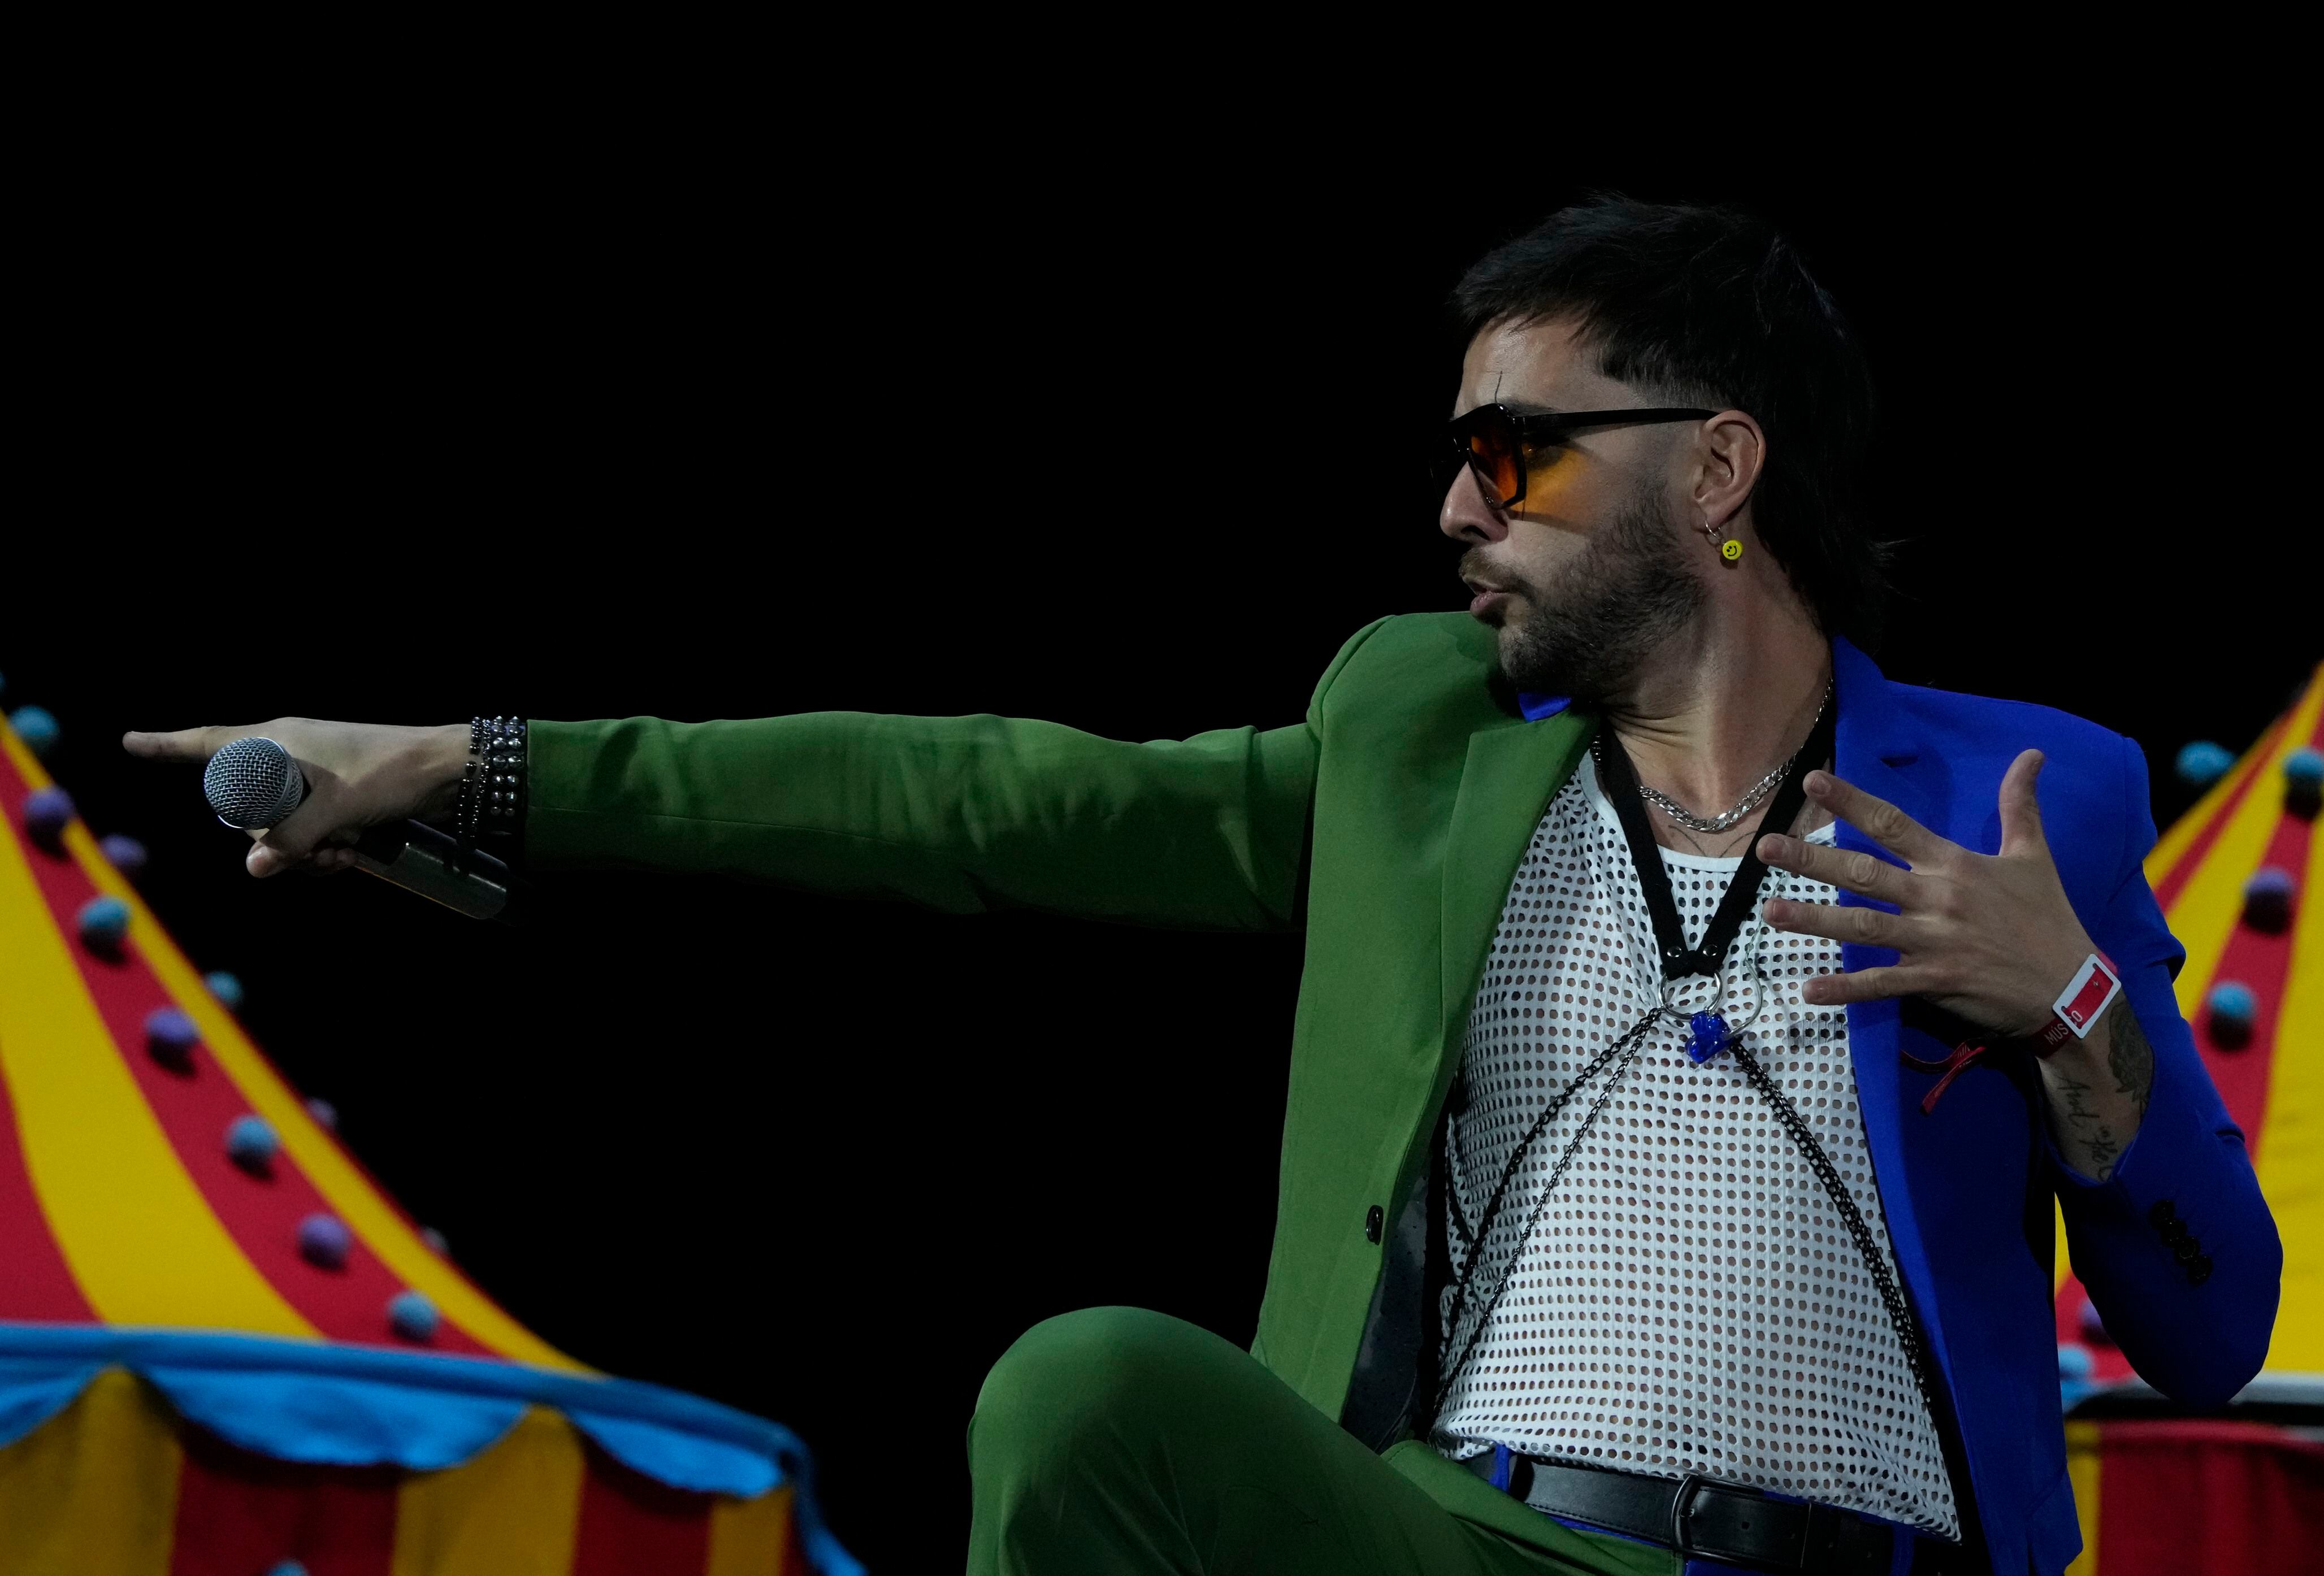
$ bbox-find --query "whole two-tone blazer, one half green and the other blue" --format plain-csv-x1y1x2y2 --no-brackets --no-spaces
527,614,2282,1571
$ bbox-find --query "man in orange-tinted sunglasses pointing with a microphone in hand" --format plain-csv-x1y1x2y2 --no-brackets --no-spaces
128,200,2282,1576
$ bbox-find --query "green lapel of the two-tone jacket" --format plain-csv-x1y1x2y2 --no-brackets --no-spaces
1438,711,1597,1060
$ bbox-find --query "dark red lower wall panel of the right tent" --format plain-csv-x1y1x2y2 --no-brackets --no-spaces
2098,1423,2324,1576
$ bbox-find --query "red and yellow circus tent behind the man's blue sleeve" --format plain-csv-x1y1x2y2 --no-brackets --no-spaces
2057,670,2324,1576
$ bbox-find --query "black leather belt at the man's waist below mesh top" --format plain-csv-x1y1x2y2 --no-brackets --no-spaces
1462,1451,1969,1576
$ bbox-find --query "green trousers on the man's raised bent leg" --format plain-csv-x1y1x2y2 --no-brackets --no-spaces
969,1309,1678,1576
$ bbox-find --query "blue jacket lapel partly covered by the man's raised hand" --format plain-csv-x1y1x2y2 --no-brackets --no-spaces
1831,639,1952,1374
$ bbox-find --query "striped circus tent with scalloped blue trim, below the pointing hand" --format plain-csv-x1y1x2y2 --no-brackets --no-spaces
0,711,860,1576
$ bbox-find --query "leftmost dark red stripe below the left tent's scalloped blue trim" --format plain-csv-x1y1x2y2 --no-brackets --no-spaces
170,1427,402,1576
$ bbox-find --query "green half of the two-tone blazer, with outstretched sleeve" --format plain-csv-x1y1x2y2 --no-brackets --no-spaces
525,614,1562,1434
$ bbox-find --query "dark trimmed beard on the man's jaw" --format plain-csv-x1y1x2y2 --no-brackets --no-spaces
1462,495,1703,709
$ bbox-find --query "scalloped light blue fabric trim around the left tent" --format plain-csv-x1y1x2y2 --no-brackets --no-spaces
0,1323,862,1576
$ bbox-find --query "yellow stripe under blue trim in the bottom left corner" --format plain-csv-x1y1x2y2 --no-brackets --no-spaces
0,1369,184,1576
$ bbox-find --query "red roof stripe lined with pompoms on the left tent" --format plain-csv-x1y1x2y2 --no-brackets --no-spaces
0,748,497,1357
